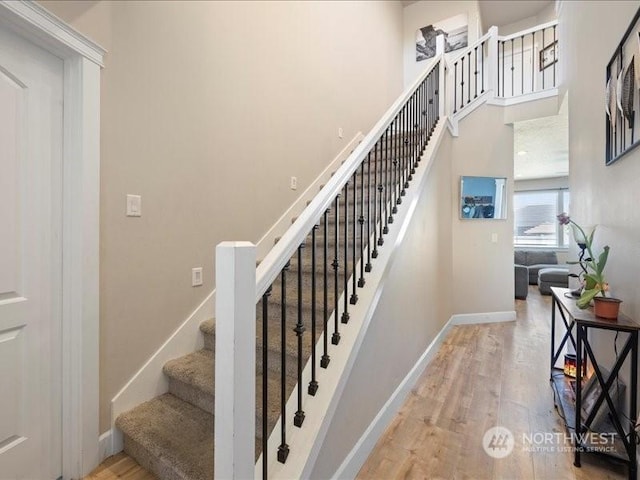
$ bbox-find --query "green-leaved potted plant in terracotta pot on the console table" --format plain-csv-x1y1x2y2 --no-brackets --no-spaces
558,213,622,318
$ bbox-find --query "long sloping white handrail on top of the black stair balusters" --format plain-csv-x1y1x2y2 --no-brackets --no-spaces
256,53,444,303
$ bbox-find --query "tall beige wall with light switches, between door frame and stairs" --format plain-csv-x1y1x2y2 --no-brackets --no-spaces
42,1,402,431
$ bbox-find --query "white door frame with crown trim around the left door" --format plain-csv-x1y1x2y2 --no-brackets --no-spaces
0,0,106,479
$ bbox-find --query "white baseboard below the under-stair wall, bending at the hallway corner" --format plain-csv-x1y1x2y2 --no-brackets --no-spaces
331,311,516,479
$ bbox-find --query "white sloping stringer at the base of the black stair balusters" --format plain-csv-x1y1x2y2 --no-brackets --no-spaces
255,117,448,479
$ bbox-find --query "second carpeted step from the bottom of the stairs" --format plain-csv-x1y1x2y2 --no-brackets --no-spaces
163,349,215,414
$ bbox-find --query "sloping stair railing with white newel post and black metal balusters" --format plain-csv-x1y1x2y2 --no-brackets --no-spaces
215,36,446,479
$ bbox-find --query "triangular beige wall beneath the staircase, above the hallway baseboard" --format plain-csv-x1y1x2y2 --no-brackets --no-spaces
311,133,453,479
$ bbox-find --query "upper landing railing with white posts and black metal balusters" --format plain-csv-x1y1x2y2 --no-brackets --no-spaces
446,21,559,116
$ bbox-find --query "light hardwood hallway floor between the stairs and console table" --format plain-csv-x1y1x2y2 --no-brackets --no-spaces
357,287,627,480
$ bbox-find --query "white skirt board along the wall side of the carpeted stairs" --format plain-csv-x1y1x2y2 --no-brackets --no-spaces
107,132,364,461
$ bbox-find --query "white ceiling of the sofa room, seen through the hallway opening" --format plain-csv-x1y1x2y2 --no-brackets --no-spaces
513,96,569,180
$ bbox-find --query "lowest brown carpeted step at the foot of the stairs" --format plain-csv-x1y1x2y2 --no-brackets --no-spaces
116,393,214,480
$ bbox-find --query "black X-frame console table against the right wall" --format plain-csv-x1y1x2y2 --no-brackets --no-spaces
550,287,640,480
